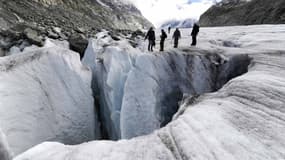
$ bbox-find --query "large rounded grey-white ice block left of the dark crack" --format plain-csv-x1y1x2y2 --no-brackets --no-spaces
0,46,98,155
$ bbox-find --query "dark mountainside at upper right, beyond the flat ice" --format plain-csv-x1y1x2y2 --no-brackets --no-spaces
199,0,285,26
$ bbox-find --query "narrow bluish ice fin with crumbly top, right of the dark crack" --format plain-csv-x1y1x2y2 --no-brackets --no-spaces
83,33,140,139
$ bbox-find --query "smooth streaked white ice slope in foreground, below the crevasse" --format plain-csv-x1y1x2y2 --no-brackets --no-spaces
15,52,285,160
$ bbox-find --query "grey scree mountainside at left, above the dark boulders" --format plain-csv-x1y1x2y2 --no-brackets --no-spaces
0,0,151,30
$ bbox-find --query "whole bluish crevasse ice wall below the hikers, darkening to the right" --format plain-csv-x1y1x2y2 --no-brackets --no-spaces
83,33,250,140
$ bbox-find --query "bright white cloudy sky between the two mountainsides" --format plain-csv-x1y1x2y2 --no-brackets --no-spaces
129,0,219,27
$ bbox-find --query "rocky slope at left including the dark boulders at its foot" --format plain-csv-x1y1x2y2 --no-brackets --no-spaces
0,0,152,55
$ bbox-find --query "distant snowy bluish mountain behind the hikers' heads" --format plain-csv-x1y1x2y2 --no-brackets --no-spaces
160,18,196,28
